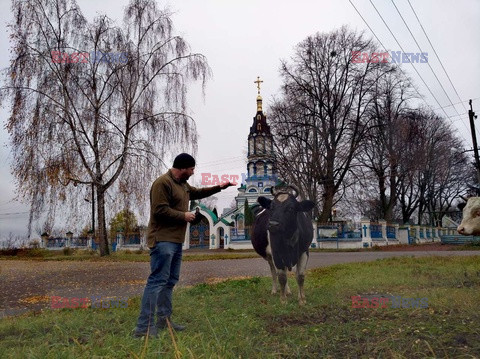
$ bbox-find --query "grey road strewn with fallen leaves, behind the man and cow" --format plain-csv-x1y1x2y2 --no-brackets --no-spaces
0,251,480,318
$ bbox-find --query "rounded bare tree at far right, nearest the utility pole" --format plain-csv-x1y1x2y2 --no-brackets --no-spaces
398,108,471,224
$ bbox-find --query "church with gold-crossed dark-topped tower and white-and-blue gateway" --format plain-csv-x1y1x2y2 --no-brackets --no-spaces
184,77,278,249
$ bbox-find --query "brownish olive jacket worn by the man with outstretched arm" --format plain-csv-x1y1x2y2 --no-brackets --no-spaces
147,170,221,248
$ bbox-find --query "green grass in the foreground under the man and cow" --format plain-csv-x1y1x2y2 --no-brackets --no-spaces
0,257,480,358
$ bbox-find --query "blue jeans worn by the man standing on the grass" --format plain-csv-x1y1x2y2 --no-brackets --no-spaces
136,242,182,331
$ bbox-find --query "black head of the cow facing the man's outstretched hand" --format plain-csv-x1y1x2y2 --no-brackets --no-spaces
257,188,315,235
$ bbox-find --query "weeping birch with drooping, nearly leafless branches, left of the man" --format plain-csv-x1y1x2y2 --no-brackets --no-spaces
2,0,210,255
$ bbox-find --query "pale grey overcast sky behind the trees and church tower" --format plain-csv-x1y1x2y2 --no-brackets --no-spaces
0,0,480,238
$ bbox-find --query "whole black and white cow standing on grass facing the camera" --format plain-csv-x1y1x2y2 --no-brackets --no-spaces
251,186,315,304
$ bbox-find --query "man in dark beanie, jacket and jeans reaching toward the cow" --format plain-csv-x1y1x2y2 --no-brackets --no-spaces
134,153,234,337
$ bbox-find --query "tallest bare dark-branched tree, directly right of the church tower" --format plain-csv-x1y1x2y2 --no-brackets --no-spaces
270,27,388,222
